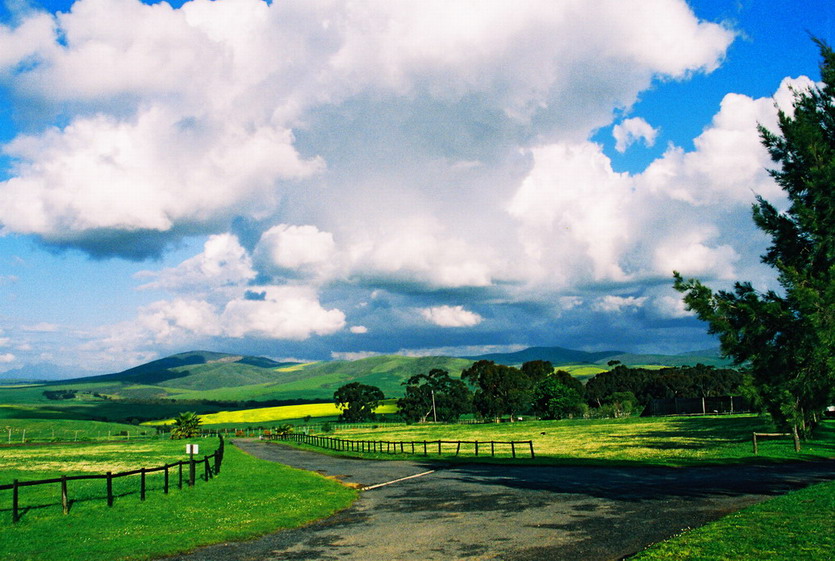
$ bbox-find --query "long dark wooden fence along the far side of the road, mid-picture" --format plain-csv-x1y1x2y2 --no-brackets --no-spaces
263,433,535,458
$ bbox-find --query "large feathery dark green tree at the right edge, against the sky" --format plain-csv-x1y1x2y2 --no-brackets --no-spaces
674,40,835,439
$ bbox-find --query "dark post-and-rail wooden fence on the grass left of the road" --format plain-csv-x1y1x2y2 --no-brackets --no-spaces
0,436,224,523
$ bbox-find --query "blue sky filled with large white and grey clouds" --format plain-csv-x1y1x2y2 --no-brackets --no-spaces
0,0,835,376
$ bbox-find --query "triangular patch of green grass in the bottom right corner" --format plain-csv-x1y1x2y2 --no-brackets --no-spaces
630,481,835,561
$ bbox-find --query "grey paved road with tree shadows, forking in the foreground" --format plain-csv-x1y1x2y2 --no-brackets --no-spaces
163,441,835,561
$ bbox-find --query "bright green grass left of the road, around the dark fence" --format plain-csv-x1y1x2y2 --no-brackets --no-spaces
0,439,356,561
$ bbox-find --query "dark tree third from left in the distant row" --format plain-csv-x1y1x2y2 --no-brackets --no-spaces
461,360,533,422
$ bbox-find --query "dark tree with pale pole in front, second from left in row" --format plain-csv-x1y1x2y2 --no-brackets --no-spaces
397,368,472,423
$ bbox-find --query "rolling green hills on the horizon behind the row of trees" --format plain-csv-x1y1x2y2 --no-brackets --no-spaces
0,347,728,421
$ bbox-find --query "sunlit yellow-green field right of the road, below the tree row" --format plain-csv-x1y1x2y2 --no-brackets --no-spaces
280,415,835,466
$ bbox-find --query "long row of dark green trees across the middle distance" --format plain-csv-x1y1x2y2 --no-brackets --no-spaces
334,360,746,423
